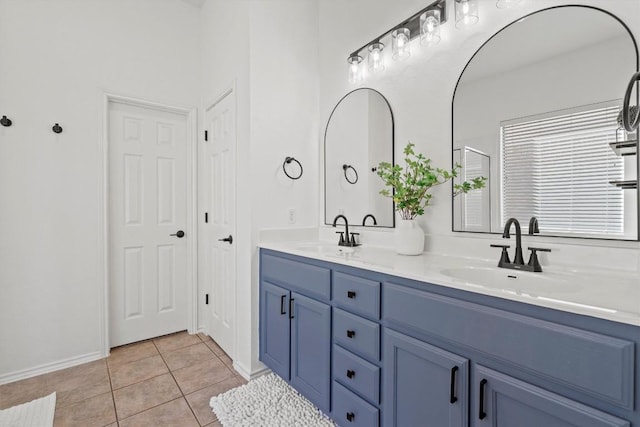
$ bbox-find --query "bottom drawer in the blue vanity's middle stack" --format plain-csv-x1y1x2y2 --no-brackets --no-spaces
331,381,380,427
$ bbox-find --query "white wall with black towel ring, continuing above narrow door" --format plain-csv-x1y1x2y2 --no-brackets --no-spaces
200,0,319,375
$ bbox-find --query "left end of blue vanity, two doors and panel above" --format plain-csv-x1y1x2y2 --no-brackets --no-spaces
260,251,331,414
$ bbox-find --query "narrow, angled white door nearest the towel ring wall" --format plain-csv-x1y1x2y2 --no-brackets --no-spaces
201,91,236,357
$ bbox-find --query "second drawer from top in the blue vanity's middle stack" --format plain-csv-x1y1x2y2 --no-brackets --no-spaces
333,308,380,360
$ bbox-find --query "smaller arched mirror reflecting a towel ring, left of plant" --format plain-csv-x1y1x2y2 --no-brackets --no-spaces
324,88,394,227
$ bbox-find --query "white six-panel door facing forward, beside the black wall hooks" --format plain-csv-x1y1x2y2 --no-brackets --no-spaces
108,101,190,347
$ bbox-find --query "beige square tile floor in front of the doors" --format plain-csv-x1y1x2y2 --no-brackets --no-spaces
0,332,246,427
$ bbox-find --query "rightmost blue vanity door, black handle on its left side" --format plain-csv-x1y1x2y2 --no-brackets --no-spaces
471,366,630,427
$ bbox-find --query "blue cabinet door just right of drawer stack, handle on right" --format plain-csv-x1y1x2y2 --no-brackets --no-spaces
383,328,469,427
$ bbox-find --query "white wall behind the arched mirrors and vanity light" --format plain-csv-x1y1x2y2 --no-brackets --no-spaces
319,0,640,269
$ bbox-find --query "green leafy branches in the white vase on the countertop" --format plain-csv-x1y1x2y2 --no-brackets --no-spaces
377,142,487,219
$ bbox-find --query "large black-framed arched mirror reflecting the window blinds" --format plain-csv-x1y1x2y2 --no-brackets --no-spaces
453,6,638,240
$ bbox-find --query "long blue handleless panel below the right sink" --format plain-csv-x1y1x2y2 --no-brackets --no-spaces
383,283,635,409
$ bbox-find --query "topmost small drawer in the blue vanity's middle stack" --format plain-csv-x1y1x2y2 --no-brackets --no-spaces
333,272,380,320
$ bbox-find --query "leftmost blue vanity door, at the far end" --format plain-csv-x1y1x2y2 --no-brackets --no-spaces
260,282,291,381
